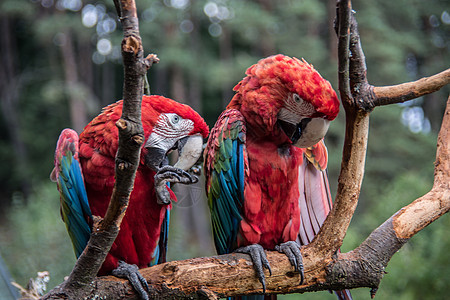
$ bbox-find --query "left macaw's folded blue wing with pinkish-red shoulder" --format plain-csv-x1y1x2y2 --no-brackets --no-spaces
50,129,92,257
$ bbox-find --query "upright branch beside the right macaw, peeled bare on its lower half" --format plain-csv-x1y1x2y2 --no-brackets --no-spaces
305,0,369,259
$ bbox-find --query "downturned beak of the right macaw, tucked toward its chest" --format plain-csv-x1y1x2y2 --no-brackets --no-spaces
278,118,330,148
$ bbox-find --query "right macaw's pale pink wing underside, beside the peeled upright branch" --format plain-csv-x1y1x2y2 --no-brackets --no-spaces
298,140,333,245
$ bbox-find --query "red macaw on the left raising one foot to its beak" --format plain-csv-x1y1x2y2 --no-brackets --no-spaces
51,96,208,298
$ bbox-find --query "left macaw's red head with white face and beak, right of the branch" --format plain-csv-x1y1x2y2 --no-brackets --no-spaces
142,95,209,171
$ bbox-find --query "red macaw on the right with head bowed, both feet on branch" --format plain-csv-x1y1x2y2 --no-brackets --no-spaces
204,54,352,298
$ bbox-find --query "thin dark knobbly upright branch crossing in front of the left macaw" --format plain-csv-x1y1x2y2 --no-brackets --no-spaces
45,0,157,299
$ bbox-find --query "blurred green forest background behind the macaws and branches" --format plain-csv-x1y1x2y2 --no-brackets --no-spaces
0,0,450,300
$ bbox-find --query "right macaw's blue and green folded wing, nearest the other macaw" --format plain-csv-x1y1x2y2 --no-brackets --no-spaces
204,109,248,254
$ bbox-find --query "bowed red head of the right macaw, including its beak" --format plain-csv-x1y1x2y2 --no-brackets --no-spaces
228,54,339,148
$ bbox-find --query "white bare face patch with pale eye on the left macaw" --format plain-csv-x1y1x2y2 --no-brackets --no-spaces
145,113,194,151
